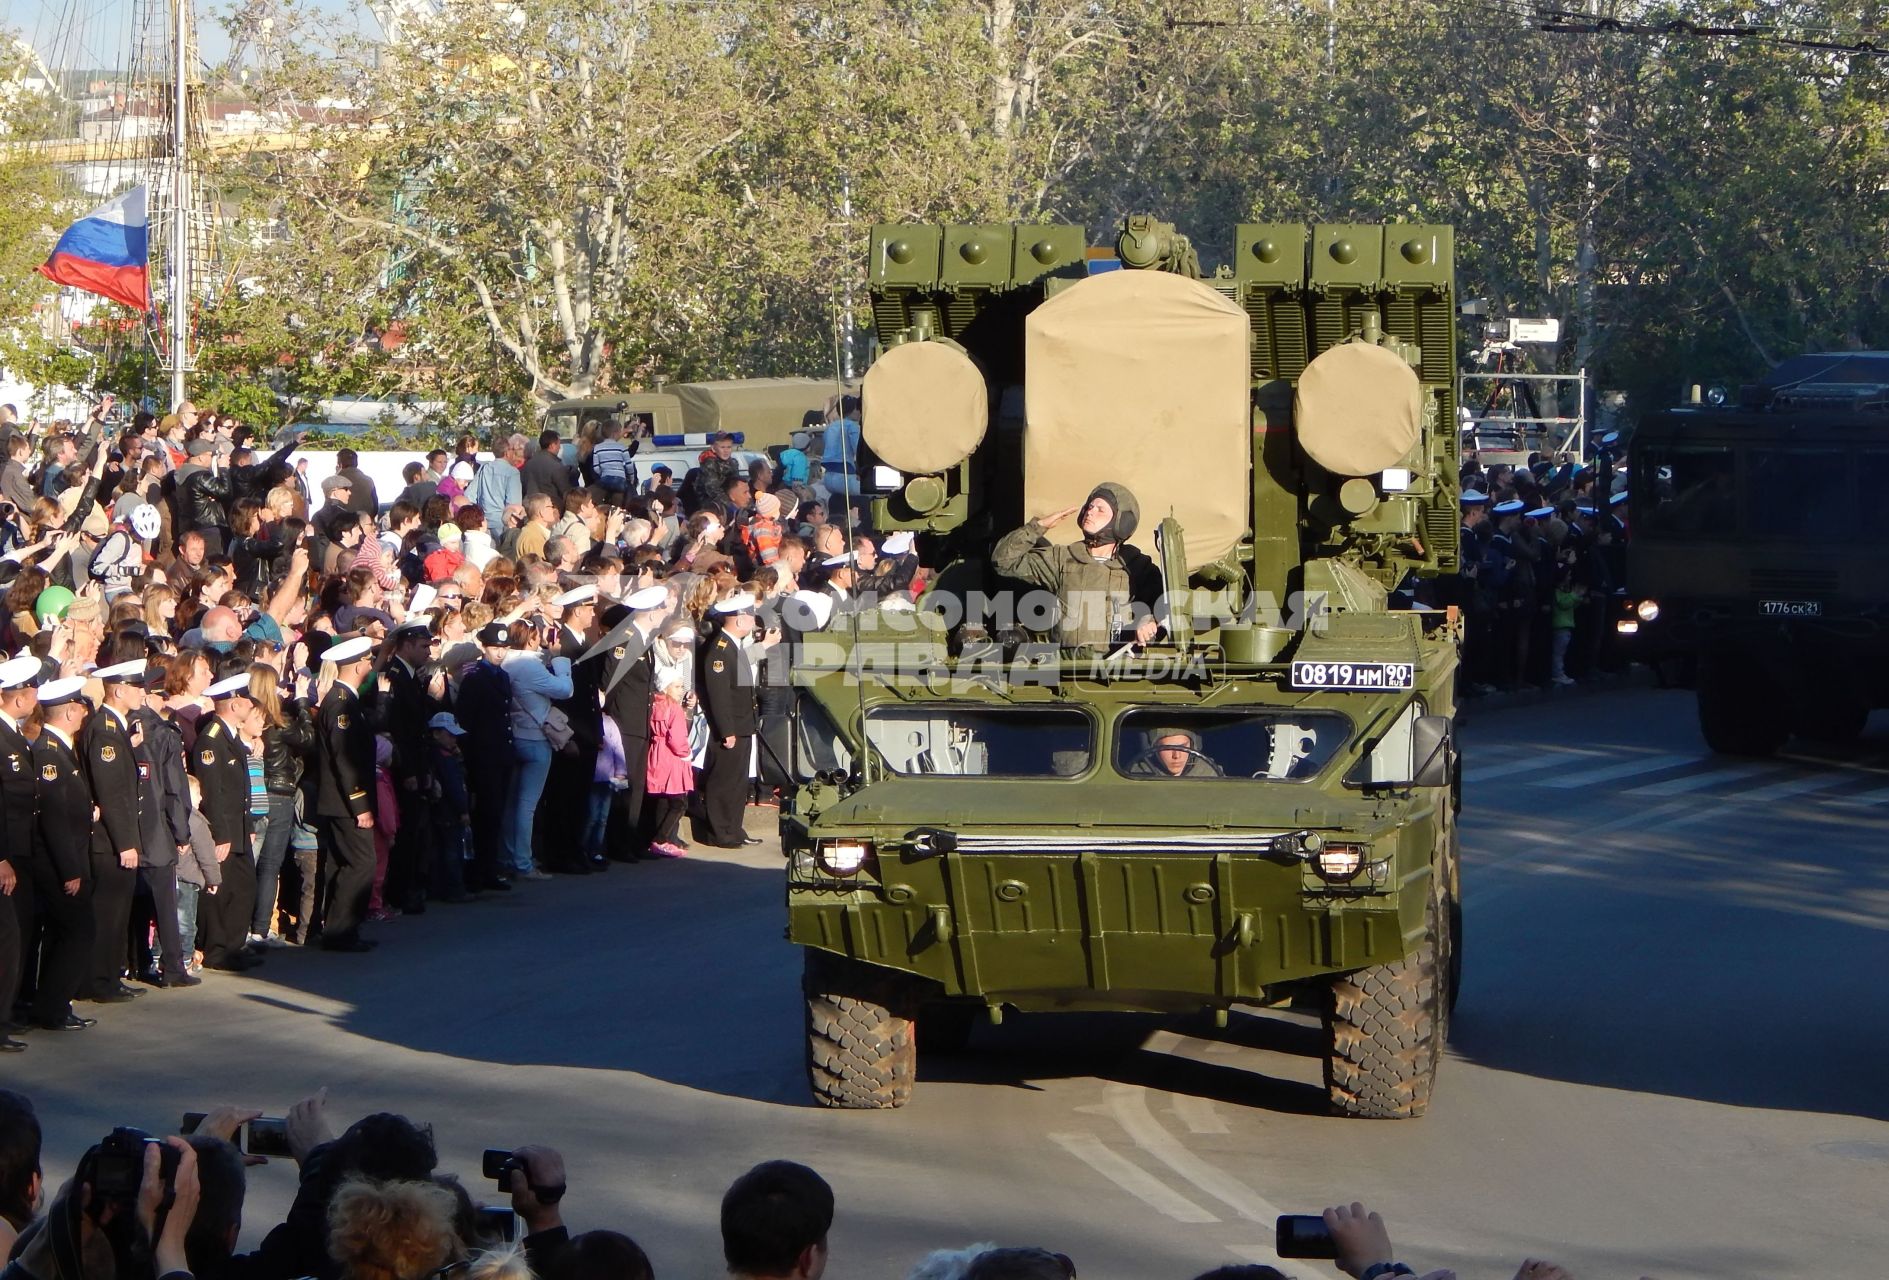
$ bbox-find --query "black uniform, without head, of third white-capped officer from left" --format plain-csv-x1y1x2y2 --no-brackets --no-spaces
79,706,144,1001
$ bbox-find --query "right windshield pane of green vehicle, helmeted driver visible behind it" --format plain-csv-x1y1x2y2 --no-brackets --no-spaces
1115,710,1351,782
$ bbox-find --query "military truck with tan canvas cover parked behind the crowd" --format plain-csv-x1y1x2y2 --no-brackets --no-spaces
544,378,835,449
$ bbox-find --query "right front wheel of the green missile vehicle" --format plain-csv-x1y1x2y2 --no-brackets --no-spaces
1324,885,1451,1120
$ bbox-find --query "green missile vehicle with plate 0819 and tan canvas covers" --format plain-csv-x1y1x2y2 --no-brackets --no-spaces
780,217,1460,1116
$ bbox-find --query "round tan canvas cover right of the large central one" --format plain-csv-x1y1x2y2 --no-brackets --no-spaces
1292,342,1422,476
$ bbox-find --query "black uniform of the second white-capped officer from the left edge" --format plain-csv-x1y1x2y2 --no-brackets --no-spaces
32,729,93,1027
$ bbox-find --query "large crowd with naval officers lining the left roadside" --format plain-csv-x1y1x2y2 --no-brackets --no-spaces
0,396,924,1052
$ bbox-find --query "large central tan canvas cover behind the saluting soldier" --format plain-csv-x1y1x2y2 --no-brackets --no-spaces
1024,270,1252,568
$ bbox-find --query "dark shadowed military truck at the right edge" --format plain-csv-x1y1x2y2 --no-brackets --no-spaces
1623,351,1889,755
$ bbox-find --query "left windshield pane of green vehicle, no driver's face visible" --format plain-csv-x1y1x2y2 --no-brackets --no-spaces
865,706,1096,778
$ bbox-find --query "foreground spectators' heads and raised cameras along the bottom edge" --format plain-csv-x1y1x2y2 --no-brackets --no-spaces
0,1089,1570,1280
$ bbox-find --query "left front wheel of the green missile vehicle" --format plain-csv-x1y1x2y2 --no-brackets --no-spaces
801,948,918,1110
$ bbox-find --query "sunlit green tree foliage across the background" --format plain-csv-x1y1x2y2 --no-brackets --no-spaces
18,0,1889,432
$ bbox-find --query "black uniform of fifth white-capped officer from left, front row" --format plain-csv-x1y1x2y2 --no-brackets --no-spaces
315,682,374,946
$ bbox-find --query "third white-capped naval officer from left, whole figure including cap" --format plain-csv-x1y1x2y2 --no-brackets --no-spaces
79,636,144,1004
